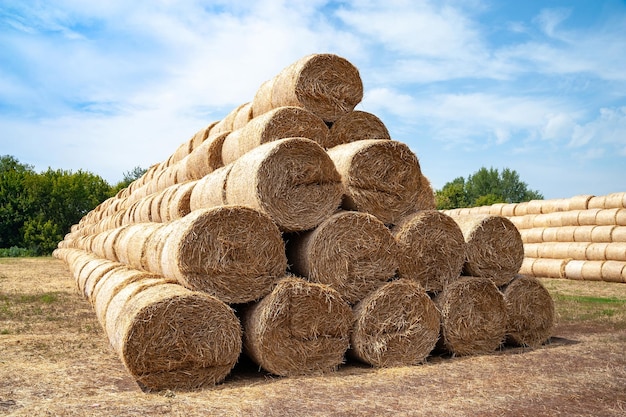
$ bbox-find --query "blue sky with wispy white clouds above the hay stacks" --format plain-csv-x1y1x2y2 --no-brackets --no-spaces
0,0,626,198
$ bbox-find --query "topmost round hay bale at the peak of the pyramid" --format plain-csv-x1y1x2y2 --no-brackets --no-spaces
252,54,363,122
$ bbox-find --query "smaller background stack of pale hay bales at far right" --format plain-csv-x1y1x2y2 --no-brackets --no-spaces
446,192,626,283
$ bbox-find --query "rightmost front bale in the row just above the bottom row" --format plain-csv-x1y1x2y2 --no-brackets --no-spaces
454,215,524,286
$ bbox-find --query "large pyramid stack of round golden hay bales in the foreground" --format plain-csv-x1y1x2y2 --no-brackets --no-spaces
55,54,553,389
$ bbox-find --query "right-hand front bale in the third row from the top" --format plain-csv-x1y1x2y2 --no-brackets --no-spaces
328,139,422,224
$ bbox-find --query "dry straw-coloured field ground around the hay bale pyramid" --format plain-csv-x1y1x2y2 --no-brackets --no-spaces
0,258,626,416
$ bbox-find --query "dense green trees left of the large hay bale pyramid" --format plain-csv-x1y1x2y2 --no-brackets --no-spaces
0,155,145,256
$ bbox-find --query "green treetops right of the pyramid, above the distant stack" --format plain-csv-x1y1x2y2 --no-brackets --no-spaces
436,167,543,210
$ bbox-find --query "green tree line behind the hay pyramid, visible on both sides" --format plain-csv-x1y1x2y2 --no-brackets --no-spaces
0,155,543,256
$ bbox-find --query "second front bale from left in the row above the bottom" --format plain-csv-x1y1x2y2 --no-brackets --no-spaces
287,211,398,304
